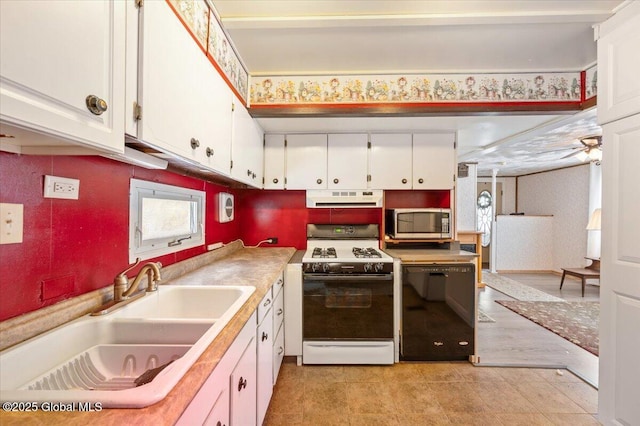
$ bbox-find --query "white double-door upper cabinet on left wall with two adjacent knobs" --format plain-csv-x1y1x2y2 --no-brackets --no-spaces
137,1,233,175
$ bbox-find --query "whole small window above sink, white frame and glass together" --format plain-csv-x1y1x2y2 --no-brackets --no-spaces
129,179,206,263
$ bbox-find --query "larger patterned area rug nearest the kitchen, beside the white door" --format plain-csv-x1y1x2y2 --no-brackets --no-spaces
496,300,600,356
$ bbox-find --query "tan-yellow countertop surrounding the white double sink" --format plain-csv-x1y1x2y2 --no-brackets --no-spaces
0,248,295,426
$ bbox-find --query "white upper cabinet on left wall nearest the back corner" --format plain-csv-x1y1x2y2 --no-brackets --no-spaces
231,103,264,188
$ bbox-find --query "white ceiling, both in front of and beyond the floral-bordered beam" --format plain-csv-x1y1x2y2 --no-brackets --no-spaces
212,0,625,176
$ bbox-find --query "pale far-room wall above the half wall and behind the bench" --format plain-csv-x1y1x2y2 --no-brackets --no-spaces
518,165,591,271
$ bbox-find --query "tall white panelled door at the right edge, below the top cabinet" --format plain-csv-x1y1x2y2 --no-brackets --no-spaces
598,114,640,425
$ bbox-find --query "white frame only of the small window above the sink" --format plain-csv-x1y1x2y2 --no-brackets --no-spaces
129,179,206,263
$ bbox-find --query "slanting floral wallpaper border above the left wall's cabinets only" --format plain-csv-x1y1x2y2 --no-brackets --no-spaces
166,0,249,104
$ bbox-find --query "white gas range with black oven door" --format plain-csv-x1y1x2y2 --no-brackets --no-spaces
302,225,399,364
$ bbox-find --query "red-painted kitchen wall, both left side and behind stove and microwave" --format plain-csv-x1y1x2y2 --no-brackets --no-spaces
0,152,450,321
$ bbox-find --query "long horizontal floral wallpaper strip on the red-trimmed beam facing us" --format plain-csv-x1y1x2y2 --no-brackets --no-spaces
249,72,582,105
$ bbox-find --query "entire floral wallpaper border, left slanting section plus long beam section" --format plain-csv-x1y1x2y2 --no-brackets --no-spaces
166,0,597,110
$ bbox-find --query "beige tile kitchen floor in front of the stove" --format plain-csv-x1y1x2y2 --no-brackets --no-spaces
264,362,599,426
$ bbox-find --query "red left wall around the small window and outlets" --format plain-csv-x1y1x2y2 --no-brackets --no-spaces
0,152,240,320
